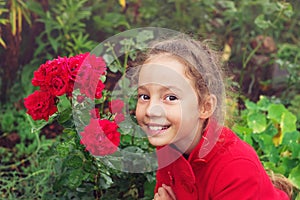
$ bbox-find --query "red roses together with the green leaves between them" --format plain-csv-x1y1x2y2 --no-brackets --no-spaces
24,53,124,156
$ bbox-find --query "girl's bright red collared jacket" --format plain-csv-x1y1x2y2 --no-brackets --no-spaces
155,125,289,200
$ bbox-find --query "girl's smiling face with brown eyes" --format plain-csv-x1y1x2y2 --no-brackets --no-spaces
136,55,205,153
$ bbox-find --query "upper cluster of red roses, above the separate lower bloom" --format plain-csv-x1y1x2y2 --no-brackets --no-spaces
24,53,106,120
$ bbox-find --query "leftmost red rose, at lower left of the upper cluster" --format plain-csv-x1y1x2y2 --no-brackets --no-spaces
24,90,57,121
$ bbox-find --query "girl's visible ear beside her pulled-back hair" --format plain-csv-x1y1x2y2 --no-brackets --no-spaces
199,94,217,119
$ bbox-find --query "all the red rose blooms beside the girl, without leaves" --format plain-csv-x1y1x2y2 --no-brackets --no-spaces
24,53,124,156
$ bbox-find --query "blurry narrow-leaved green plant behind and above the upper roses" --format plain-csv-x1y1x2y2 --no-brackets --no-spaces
29,0,95,59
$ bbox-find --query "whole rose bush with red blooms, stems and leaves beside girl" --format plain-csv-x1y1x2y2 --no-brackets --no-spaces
24,30,156,199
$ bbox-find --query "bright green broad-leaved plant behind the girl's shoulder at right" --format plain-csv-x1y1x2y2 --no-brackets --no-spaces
233,96,300,194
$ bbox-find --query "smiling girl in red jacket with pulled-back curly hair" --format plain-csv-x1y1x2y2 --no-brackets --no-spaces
136,37,289,200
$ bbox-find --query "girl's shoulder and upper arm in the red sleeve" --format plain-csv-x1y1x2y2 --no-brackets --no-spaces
206,129,284,200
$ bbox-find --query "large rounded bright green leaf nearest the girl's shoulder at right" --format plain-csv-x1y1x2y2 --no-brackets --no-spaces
247,112,267,133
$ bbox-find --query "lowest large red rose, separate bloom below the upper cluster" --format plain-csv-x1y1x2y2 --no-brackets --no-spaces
80,119,120,156
